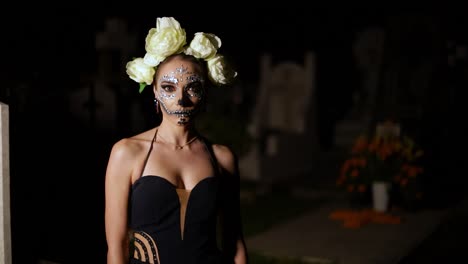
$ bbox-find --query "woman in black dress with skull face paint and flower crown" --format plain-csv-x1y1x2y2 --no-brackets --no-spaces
105,18,247,264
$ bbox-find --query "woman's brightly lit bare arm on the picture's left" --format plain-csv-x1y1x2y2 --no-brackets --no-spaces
105,140,132,264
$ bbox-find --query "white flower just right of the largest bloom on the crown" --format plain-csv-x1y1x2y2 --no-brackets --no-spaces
185,32,221,59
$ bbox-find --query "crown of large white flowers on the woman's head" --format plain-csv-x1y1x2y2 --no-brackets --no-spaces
126,17,237,93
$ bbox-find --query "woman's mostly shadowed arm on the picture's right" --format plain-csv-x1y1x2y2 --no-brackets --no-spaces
213,145,248,264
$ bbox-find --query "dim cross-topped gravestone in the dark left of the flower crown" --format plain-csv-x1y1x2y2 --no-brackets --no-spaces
70,18,136,131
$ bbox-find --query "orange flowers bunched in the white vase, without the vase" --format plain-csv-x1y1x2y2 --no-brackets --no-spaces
336,122,424,206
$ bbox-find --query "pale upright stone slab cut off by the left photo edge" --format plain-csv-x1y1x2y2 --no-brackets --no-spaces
0,102,12,264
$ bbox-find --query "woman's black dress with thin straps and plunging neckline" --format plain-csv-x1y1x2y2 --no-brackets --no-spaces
129,133,236,264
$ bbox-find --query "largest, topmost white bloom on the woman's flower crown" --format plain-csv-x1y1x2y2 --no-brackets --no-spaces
145,17,187,58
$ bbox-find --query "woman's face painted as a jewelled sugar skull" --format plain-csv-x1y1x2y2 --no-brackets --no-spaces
155,60,205,124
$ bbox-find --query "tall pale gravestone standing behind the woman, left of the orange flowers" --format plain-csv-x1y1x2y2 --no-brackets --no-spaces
239,52,318,184
